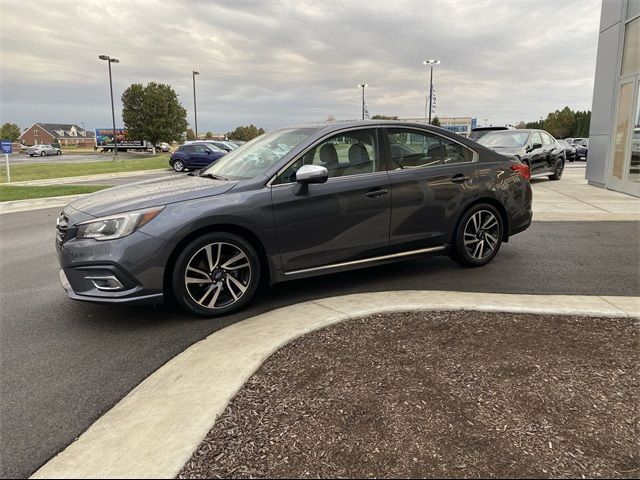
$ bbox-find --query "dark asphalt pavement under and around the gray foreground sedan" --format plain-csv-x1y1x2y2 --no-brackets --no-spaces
0,202,640,477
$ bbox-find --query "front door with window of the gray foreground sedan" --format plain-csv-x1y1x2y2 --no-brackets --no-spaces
271,128,391,272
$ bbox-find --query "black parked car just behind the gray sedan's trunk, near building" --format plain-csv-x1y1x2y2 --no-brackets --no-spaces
478,129,567,180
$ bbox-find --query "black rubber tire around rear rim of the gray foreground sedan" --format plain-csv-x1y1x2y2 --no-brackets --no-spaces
449,203,504,267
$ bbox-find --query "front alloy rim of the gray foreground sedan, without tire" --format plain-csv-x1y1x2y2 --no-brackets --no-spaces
184,242,252,309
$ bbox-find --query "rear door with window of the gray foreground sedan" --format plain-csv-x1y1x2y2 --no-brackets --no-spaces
385,127,477,250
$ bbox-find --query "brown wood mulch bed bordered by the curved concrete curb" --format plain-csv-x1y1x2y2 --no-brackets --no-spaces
178,312,640,478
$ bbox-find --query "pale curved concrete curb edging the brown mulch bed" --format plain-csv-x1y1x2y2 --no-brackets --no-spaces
31,291,640,478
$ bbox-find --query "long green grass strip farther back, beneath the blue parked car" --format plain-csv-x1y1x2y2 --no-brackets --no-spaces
0,155,169,183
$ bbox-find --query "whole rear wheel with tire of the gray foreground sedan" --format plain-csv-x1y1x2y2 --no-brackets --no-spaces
450,203,503,267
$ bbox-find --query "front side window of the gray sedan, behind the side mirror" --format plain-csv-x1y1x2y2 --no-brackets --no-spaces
275,129,380,184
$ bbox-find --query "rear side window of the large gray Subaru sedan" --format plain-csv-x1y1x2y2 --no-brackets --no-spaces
387,128,473,169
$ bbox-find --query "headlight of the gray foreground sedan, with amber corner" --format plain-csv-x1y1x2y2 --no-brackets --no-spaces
76,206,164,241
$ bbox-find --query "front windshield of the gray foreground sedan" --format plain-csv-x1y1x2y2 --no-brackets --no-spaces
202,128,318,180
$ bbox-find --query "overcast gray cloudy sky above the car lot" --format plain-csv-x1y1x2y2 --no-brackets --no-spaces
0,0,600,132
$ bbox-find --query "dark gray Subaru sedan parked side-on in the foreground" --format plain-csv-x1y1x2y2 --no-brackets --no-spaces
55,121,532,317
